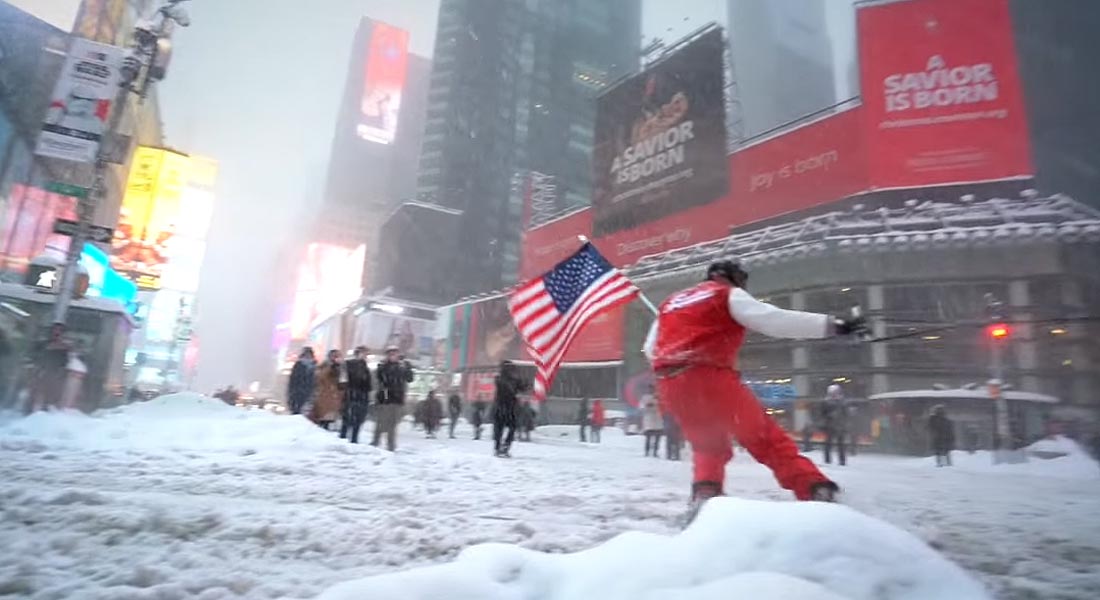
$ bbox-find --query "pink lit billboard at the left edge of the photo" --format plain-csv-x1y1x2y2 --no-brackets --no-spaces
0,184,76,271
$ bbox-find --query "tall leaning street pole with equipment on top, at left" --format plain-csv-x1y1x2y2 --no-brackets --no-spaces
53,0,190,327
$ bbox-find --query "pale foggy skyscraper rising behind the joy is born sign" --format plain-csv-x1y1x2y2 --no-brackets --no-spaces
726,0,836,137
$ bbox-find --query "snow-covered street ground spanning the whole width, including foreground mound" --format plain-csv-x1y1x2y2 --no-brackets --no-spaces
0,396,1100,600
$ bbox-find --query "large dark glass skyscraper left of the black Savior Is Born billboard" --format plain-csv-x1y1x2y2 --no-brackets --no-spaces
417,0,641,298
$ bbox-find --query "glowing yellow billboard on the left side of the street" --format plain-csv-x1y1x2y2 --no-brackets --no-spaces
111,146,189,290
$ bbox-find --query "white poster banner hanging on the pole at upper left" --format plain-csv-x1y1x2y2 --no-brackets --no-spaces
35,37,123,163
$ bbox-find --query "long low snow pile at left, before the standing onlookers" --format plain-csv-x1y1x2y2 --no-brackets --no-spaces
0,393,371,454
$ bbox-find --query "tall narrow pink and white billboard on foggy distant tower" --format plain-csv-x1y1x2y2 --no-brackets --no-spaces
355,21,409,144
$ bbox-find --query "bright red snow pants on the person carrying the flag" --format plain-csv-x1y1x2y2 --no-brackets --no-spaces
657,366,828,500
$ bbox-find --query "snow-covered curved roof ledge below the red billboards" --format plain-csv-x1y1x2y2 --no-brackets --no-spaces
627,190,1100,280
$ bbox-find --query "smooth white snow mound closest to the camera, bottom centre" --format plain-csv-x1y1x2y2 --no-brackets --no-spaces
319,498,989,600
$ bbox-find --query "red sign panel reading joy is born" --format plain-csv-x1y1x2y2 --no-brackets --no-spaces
727,106,868,227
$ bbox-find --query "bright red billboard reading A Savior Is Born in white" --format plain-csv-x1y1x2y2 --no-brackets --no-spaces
857,0,1033,188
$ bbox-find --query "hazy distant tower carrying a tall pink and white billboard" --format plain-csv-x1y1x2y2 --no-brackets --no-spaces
310,18,431,279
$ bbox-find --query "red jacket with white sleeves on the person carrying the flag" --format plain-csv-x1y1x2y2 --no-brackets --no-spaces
645,281,832,369
